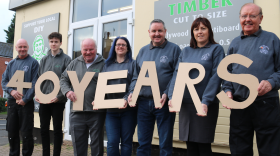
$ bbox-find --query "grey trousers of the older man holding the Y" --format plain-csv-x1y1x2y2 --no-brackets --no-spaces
70,112,106,156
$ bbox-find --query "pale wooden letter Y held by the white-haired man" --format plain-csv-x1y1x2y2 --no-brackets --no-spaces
67,71,95,111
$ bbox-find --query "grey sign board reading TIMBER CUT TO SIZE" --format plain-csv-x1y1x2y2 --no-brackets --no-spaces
154,0,253,52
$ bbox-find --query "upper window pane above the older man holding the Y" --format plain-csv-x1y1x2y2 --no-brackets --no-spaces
73,0,99,22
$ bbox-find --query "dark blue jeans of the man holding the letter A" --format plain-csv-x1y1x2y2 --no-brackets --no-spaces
137,99,176,156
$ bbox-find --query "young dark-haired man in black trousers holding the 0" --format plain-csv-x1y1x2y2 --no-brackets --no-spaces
35,32,71,156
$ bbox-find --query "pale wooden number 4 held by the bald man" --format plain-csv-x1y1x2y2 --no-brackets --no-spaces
7,70,32,100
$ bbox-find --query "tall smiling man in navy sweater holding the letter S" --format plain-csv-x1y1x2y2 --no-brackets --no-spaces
223,3,280,156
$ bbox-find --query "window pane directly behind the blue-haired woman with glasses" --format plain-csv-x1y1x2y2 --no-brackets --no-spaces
102,20,127,59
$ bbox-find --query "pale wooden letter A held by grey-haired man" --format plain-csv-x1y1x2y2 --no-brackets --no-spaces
130,61,161,108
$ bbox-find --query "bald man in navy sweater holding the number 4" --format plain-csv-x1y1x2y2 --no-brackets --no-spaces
1,39,39,156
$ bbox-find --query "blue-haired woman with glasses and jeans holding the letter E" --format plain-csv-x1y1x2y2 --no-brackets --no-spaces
93,37,137,156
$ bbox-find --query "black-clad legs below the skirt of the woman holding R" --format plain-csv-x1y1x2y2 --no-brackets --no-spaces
186,141,212,156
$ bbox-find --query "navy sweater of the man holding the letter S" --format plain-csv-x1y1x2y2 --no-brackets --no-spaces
223,27,280,100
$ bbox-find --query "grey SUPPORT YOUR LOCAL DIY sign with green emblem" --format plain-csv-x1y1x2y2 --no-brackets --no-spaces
21,13,59,111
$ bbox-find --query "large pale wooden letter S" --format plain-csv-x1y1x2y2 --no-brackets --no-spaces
217,54,259,109
